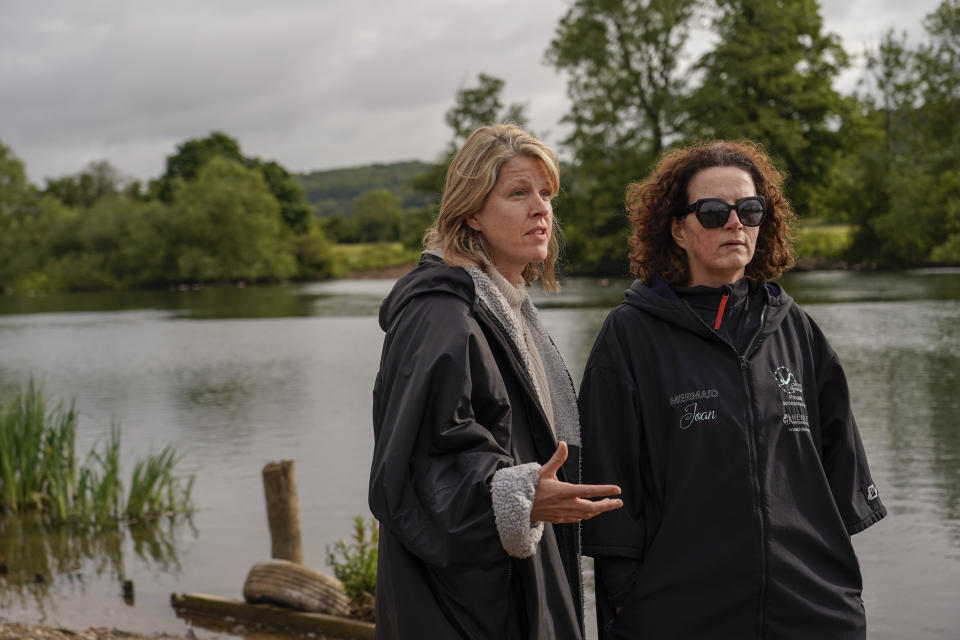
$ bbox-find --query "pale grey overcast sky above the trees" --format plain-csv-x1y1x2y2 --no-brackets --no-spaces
0,0,939,186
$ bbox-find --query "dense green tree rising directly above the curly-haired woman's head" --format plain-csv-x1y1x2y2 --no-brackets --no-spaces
688,0,848,215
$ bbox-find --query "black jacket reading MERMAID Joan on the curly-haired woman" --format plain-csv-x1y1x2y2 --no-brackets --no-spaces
579,280,886,640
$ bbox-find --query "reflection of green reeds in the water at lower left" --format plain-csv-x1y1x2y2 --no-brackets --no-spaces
0,514,197,618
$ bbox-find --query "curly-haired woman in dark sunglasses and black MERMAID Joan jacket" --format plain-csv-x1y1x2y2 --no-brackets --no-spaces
579,142,886,639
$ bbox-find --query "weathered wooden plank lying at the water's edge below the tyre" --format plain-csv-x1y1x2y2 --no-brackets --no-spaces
170,593,374,640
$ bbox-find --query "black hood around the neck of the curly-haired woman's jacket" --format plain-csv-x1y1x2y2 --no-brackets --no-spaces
624,276,793,335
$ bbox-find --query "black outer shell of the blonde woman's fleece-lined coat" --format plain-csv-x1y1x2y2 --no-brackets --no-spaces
369,254,582,640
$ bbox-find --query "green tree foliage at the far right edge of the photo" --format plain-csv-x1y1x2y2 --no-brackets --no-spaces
830,0,960,266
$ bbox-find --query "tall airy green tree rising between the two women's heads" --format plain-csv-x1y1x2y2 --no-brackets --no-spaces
546,0,702,274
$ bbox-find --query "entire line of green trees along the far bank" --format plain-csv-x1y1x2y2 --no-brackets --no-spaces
0,0,960,291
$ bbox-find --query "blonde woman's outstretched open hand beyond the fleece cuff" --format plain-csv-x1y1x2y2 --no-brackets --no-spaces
530,442,623,524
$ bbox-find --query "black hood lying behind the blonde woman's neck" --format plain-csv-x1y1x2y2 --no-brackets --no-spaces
380,252,476,331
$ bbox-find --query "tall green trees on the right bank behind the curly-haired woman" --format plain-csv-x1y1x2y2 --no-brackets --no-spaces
546,0,960,273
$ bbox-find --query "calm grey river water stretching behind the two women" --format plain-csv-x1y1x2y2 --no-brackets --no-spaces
0,270,960,640
